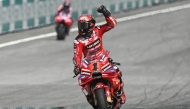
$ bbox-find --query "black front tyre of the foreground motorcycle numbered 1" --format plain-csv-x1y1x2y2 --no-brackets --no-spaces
95,89,107,109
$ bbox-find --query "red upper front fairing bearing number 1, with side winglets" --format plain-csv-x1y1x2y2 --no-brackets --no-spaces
78,52,117,86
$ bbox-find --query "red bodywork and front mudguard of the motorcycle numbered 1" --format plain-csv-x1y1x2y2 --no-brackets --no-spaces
78,52,120,108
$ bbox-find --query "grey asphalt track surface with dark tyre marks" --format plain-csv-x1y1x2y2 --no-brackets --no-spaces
0,1,190,109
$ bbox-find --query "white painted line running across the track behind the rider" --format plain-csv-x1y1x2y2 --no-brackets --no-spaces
0,4,190,48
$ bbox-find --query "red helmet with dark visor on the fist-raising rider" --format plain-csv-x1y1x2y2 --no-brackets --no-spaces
78,14,96,36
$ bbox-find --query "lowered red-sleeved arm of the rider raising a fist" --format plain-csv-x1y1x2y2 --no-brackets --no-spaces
73,39,83,67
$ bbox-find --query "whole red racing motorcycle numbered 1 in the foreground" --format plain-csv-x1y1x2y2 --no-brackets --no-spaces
73,51,122,109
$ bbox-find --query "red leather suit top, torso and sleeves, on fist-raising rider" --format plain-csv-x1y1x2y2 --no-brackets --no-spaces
73,16,117,66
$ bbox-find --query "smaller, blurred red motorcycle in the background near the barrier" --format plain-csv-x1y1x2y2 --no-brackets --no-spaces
55,12,72,40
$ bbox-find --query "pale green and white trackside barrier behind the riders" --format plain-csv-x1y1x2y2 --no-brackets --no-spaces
0,0,183,34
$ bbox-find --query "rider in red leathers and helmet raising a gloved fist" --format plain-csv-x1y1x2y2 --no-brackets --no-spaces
73,5,126,104
